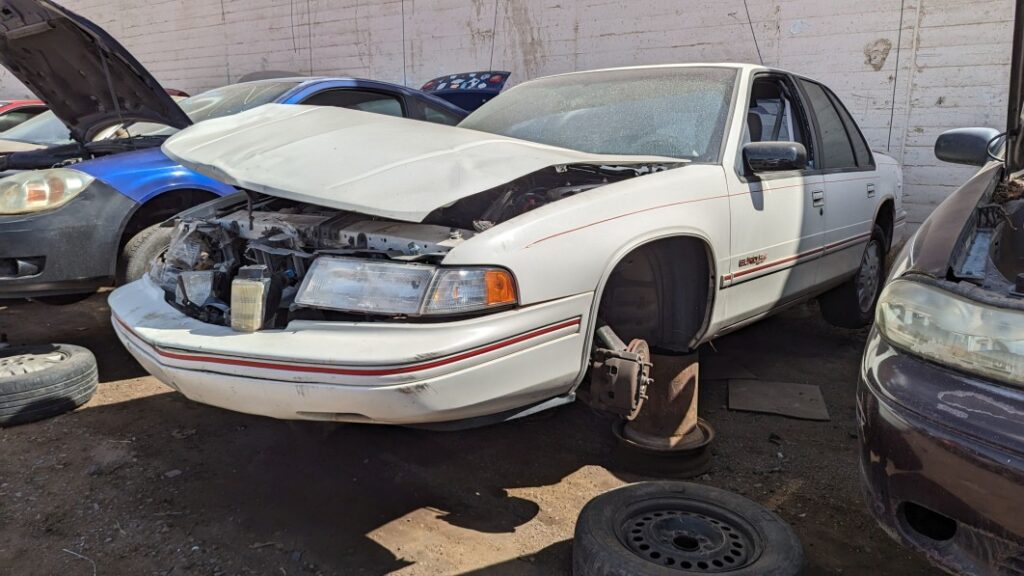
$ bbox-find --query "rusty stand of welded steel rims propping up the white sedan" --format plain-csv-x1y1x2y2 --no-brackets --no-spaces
613,353,715,478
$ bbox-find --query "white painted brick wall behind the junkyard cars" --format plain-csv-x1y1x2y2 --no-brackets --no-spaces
6,0,1013,222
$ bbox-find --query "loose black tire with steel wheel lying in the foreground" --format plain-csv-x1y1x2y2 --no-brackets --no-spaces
572,482,804,576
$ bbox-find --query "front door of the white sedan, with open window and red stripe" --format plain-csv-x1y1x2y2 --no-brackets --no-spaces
722,73,824,322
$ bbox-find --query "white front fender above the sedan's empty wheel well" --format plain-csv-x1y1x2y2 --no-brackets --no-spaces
444,165,730,377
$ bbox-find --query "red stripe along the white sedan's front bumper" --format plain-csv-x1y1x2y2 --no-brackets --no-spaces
114,316,582,376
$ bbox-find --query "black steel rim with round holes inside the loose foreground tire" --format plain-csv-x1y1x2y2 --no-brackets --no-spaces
620,499,761,574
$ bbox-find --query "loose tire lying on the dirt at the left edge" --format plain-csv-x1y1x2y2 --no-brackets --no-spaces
0,344,98,427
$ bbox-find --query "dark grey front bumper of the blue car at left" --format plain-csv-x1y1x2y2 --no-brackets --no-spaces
0,180,136,299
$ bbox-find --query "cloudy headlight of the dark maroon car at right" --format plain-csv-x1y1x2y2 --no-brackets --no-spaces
876,280,1024,385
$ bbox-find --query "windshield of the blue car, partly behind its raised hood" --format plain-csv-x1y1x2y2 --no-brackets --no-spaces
129,80,299,136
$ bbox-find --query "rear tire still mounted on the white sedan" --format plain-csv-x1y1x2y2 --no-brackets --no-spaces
818,225,886,328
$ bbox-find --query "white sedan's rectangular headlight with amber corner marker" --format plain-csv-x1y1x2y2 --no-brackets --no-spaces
295,256,518,317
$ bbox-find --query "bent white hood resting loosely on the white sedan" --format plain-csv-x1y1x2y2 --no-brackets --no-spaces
163,104,685,222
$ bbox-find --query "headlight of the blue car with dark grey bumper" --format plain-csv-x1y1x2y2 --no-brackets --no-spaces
0,168,95,214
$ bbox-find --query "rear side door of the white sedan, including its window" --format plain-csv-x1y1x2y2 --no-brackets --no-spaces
798,78,881,285
